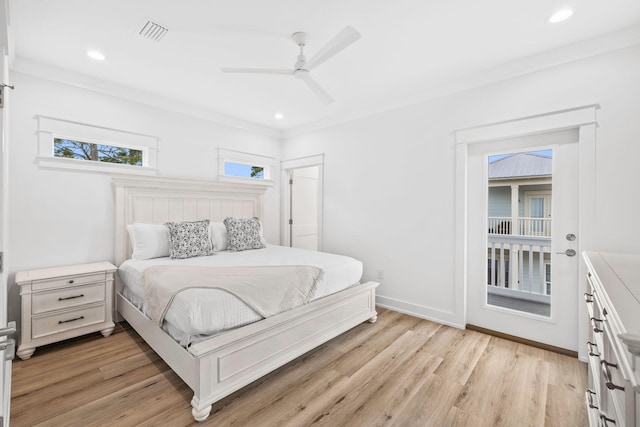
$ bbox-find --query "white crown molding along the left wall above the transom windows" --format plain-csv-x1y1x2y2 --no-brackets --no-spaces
11,56,282,139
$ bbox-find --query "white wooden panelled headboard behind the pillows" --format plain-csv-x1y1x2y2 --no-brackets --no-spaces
111,174,268,265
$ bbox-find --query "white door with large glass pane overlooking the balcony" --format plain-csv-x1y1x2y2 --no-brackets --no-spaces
467,131,579,351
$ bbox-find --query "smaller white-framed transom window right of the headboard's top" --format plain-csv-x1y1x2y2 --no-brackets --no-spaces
218,148,275,185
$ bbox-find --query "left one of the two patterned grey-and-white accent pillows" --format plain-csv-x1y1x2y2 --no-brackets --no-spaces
165,219,213,259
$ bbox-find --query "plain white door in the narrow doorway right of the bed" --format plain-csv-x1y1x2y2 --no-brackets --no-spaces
289,166,320,251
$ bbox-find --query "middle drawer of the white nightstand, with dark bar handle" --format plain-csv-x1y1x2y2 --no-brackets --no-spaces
31,282,105,314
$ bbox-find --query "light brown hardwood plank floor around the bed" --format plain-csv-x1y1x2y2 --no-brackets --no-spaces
11,309,587,427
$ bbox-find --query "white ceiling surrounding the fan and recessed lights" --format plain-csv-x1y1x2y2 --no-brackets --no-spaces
11,0,640,134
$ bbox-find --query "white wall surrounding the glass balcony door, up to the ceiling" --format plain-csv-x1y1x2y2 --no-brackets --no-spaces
282,46,640,324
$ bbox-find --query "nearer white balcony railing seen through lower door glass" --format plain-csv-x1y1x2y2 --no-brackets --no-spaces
487,233,551,304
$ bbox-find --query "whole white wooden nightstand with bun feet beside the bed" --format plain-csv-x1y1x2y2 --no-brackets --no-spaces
16,262,117,360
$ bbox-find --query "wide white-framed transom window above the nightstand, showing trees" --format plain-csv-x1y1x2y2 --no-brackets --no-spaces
36,116,158,175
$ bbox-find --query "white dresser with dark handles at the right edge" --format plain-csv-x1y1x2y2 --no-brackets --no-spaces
583,252,640,427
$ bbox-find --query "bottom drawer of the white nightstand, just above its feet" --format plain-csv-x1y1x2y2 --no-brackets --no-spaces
31,304,106,339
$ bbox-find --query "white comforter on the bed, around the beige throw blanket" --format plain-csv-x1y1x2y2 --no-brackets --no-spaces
118,245,362,346
